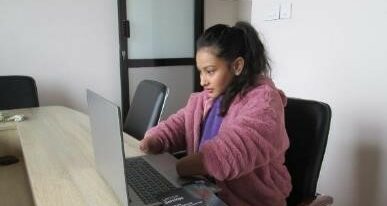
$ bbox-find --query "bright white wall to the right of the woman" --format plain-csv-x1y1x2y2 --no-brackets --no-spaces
252,0,387,206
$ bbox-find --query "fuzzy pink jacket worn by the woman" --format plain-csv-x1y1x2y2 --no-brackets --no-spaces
146,78,291,206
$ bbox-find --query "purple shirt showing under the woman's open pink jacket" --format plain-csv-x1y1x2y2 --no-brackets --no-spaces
199,97,223,149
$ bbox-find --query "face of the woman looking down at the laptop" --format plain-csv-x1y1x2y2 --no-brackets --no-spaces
196,47,234,98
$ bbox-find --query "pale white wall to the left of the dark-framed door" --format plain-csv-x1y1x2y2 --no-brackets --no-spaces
0,0,121,112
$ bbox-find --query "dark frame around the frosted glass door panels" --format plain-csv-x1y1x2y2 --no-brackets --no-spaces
117,0,204,119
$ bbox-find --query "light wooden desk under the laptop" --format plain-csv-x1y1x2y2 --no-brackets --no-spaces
0,106,142,206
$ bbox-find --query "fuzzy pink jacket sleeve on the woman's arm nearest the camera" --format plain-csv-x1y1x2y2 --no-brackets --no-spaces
201,89,288,180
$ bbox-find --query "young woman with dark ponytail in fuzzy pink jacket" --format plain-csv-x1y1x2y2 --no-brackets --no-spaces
140,22,291,206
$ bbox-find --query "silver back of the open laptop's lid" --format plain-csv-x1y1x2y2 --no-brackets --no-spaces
87,89,128,205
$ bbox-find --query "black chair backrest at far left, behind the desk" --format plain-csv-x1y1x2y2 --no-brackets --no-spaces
0,76,39,110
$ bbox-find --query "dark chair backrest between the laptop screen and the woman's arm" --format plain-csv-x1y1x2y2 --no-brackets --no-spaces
123,80,168,140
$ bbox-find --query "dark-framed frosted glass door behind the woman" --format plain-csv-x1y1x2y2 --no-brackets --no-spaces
119,0,203,118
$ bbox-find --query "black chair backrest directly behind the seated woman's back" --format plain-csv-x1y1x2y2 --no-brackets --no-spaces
285,98,332,206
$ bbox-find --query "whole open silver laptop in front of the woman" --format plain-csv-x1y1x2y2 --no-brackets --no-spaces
87,89,184,206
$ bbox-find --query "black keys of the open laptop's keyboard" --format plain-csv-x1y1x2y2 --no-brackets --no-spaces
125,157,176,204
